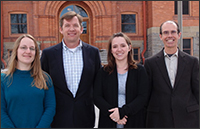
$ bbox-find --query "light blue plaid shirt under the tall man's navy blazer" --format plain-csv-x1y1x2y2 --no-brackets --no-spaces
62,41,83,97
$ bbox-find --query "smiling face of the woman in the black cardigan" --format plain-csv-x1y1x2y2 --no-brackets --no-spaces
111,37,131,61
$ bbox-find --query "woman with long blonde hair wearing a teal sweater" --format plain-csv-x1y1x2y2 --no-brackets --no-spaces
1,34,56,128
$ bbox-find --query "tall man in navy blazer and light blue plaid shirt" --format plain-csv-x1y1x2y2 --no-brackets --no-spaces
41,11,101,128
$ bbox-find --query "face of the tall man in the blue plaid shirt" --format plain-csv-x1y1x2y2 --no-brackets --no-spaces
60,16,83,48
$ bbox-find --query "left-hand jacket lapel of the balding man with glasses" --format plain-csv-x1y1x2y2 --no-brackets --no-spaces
156,50,172,89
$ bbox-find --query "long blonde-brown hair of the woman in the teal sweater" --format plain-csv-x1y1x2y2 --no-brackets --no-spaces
5,34,48,89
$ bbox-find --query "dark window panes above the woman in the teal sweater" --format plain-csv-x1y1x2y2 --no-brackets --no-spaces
10,14,27,34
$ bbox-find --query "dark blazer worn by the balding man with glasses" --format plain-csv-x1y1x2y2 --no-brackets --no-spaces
144,50,199,128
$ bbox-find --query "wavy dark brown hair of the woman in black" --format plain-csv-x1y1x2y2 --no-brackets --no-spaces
104,32,137,74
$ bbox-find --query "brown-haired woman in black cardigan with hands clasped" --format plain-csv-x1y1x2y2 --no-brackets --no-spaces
94,32,149,128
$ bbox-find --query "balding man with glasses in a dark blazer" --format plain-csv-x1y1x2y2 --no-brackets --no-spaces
144,21,199,128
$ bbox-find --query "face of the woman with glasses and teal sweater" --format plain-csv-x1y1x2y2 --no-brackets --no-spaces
17,37,36,69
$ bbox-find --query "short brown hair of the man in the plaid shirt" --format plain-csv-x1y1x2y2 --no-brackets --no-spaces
59,11,83,28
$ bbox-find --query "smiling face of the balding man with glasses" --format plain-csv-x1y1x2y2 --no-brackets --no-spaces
160,22,181,51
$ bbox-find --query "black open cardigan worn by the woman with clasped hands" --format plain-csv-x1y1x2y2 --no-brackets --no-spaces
94,65,149,128
